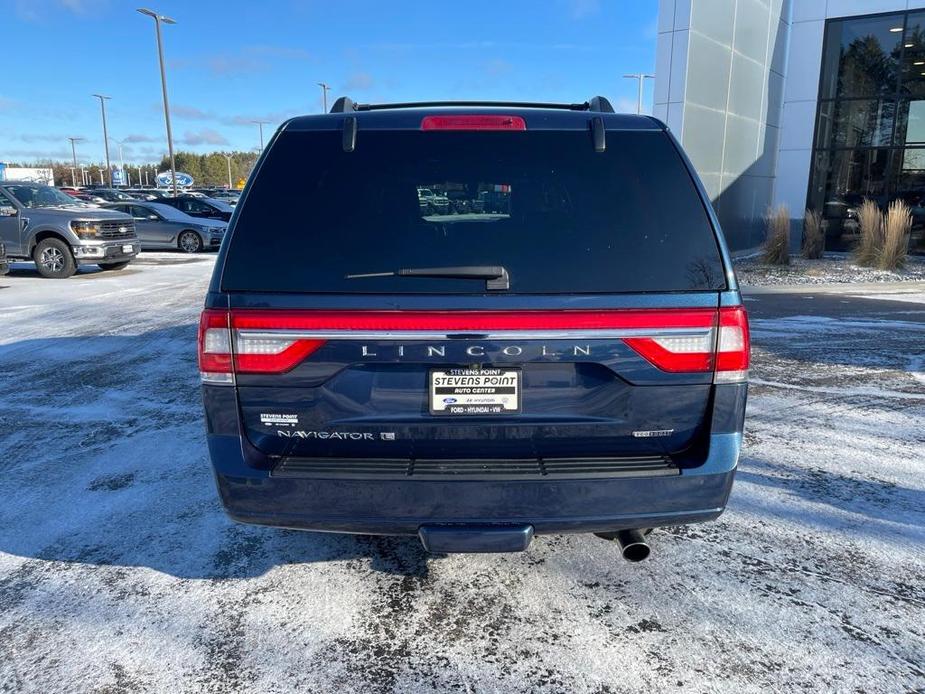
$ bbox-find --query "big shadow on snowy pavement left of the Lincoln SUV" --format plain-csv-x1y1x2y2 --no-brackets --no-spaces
0,326,428,580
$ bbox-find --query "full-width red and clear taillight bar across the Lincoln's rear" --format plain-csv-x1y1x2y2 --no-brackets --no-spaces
199,306,749,385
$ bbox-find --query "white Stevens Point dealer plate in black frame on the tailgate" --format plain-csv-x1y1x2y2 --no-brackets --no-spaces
427,366,523,417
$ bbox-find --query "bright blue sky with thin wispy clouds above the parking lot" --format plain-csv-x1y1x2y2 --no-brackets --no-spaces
0,0,658,162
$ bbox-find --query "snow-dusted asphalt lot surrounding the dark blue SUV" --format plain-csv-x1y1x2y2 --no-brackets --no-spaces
0,253,925,694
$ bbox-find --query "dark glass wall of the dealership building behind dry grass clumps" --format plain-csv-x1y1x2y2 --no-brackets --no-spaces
807,11,925,253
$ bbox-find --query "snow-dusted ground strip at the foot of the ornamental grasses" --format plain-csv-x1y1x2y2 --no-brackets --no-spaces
732,253,925,287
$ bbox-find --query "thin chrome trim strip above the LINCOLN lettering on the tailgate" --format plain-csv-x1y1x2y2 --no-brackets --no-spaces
235,328,713,342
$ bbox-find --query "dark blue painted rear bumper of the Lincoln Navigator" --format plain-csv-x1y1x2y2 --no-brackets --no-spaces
209,433,742,535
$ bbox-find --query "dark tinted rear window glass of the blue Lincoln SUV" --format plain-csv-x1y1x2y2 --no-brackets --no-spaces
222,128,725,294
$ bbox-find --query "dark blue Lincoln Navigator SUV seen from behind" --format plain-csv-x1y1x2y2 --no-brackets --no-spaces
199,97,749,559
